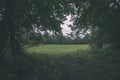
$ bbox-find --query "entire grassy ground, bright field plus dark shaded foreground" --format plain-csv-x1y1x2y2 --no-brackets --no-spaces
0,45,120,80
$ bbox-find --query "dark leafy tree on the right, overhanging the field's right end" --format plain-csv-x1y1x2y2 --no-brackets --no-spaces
71,0,120,48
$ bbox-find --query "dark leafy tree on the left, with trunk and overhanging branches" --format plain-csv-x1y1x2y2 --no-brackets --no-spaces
0,0,72,55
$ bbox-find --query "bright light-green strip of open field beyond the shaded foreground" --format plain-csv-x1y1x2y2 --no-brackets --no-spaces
27,45,89,54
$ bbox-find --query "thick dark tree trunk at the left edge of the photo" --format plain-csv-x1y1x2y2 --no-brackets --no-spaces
0,0,16,56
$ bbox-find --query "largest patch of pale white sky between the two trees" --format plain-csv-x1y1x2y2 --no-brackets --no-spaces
61,15,73,35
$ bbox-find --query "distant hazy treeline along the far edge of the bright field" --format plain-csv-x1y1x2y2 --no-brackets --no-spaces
43,34,89,44
